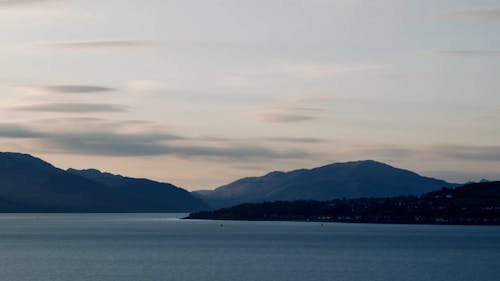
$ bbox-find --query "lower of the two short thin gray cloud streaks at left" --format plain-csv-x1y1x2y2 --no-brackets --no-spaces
13,103,129,113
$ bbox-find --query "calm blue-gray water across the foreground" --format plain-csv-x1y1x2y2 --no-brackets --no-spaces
0,214,500,281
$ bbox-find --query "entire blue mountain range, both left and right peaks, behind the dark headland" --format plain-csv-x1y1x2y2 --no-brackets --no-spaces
0,152,457,212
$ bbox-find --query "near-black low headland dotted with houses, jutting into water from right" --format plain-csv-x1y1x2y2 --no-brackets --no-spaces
187,181,500,225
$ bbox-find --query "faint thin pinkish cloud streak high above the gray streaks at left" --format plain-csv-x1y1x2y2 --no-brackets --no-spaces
37,40,155,49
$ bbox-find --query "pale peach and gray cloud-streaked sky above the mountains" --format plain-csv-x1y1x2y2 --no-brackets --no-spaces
0,0,500,190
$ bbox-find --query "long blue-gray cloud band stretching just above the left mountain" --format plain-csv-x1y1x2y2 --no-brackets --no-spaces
0,121,310,159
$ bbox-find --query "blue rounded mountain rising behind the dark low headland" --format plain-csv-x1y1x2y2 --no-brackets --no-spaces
193,160,455,208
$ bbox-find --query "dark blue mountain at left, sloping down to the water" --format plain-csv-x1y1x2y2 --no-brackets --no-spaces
0,152,205,212
